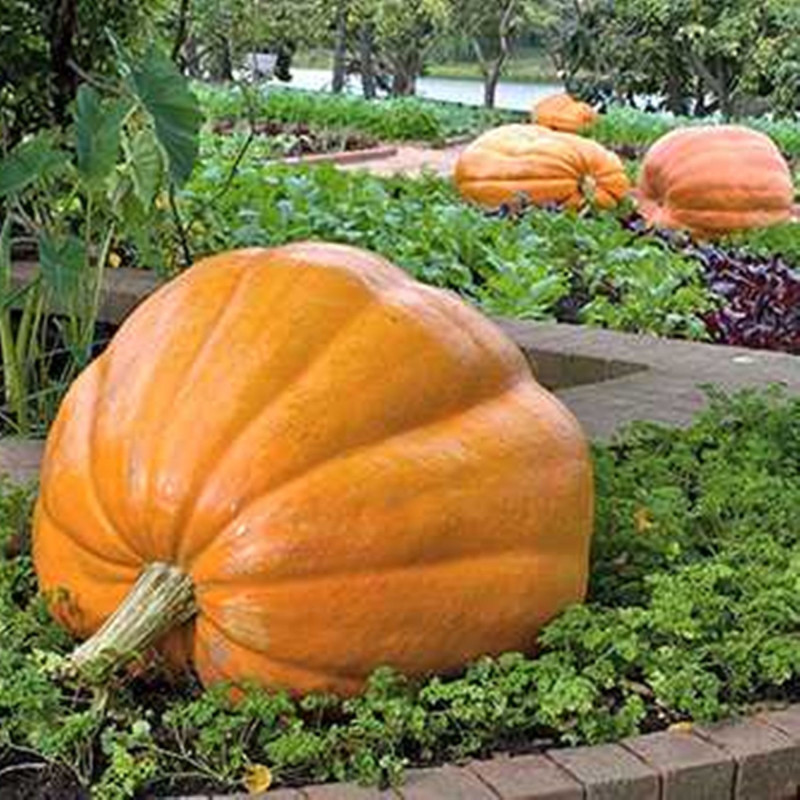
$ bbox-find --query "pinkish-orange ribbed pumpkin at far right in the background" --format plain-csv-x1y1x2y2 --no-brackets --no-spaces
637,125,793,235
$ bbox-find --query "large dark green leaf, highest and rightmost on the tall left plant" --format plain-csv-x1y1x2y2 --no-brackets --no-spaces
131,47,202,186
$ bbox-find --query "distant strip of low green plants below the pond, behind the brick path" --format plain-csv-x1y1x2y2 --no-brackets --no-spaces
194,84,523,143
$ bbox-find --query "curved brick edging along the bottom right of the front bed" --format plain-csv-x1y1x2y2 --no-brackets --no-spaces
175,704,800,800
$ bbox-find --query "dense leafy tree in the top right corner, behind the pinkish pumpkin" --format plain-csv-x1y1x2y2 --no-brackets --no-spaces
544,0,800,118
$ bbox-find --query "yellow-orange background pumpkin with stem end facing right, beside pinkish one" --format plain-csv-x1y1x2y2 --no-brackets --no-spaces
455,125,630,208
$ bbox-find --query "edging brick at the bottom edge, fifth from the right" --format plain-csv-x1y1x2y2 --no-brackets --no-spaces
468,755,583,800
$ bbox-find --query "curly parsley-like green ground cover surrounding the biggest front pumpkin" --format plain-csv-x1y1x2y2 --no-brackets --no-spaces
0,390,800,800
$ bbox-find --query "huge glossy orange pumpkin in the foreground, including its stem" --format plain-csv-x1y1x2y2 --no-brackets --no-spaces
34,243,592,693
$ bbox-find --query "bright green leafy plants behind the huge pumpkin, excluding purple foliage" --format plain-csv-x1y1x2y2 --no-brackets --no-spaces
184,163,713,338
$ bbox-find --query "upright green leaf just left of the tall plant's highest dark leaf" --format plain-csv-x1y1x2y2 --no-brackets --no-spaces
75,84,131,186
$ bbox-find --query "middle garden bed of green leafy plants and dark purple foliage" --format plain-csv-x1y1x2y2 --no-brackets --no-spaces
181,158,800,353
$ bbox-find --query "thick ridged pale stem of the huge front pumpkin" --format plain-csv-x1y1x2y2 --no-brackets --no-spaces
69,562,197,681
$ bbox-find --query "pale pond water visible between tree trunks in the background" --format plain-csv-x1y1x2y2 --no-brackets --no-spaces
280,69,563,111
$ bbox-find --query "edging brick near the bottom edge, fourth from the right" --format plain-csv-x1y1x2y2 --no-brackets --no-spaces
547,744,659,800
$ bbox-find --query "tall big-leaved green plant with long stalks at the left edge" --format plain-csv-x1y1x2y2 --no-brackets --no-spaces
0,45,200,434
